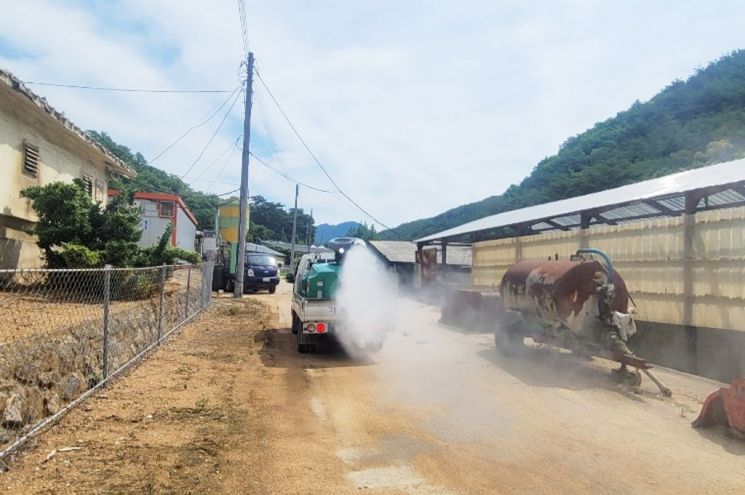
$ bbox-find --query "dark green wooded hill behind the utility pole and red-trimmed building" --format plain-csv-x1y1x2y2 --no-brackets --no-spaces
88,131,315,242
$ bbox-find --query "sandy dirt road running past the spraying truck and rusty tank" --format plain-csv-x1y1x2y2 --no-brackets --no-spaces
0,284,745,494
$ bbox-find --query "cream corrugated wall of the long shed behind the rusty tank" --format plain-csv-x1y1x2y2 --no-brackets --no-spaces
472,207,745,331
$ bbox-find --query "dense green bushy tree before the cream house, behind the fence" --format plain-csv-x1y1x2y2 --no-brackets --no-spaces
21,179,141,268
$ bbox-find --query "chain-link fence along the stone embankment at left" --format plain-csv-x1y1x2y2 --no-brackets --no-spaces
0,263,213,459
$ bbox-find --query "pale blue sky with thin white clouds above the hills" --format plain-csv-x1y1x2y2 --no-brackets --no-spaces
0,0,745,230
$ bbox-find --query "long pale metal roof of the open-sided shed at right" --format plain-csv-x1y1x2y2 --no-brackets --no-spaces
415,159,745,242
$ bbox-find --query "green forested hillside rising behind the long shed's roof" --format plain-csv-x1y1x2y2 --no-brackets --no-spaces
380,50,745,239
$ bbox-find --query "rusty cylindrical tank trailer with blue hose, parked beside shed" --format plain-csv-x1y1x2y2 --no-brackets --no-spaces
494,249,672,396
